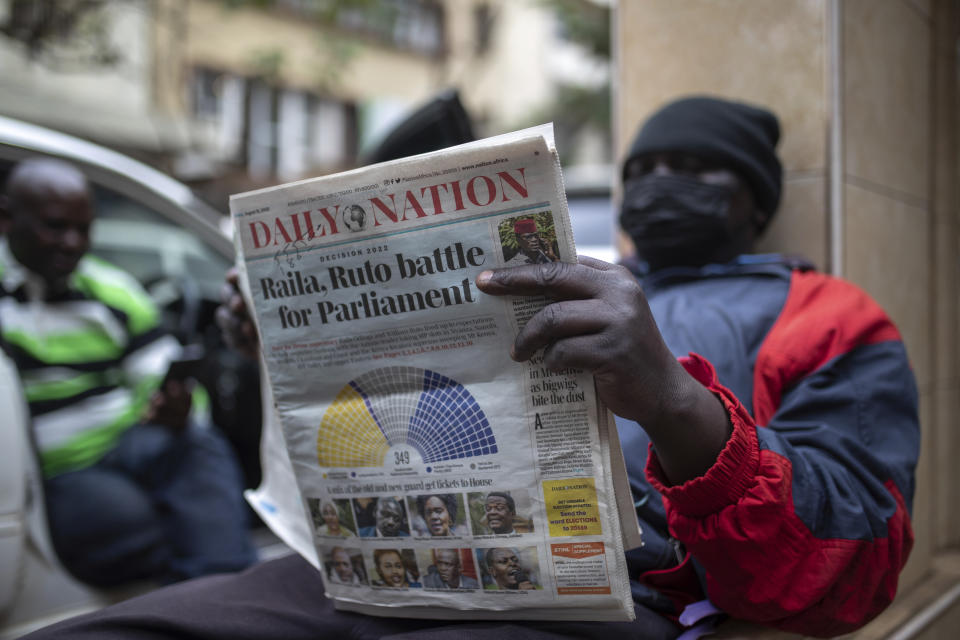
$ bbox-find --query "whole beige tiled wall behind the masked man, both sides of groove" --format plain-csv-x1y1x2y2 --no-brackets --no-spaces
614,0,960,624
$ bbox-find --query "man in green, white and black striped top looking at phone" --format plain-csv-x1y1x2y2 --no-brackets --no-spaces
0,159,254,586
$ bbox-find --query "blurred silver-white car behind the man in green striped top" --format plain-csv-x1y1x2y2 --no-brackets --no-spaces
0,117,261,638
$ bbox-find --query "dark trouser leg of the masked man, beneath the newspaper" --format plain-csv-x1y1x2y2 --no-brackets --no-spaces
28,556,679,640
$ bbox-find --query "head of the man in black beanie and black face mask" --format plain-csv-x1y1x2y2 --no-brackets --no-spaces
620,98,781,270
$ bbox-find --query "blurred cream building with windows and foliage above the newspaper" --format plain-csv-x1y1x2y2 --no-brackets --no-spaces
0,0,610,210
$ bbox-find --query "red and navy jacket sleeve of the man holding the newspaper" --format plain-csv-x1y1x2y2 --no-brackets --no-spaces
647,272,919,636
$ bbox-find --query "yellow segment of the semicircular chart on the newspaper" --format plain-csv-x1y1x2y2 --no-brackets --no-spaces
317,385,390,467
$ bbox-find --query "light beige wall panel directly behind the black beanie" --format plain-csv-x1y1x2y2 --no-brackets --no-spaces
614,0,827,267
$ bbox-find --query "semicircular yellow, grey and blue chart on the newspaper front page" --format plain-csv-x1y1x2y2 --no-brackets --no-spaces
317,367,497,467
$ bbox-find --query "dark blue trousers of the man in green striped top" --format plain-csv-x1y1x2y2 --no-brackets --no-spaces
45,425,255,586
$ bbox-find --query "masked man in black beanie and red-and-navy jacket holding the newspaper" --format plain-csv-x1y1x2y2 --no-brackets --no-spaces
26,97,919,640
